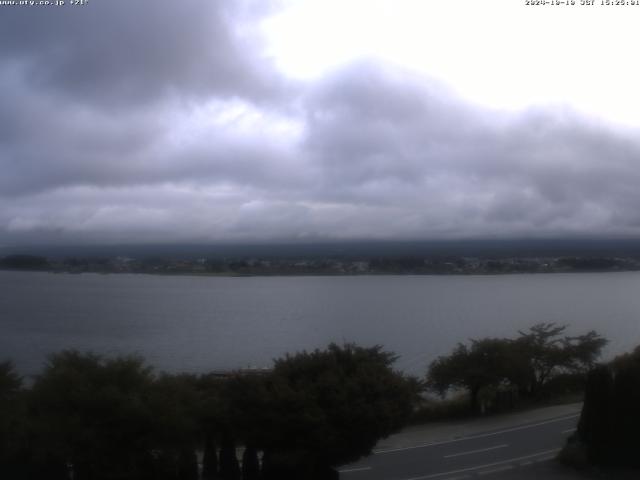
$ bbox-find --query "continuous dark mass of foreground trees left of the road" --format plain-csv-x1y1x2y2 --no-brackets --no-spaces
0,344,418,480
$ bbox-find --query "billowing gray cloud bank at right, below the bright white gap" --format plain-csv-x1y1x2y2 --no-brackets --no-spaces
298,62,640,236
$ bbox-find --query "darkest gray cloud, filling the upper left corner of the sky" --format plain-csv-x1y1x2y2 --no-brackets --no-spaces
0,0,276,107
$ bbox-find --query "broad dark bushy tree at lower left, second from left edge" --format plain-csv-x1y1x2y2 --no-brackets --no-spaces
31,351,157,480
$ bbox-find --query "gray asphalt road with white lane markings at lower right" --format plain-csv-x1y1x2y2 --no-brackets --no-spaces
340,413,578,480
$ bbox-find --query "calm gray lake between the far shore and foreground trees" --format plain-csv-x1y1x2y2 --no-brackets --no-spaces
0,271,640,375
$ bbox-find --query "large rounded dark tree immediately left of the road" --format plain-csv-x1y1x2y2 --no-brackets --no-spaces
256,344,417,479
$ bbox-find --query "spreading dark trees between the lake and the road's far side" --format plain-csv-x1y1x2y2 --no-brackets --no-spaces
426,323,607,413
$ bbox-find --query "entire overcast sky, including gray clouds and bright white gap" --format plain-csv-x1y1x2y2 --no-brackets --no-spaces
0,0,640,245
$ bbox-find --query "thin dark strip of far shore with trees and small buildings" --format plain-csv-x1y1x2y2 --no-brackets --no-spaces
0,255,640,276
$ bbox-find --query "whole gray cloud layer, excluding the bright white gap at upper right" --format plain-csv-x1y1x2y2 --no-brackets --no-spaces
0,0,640,243
